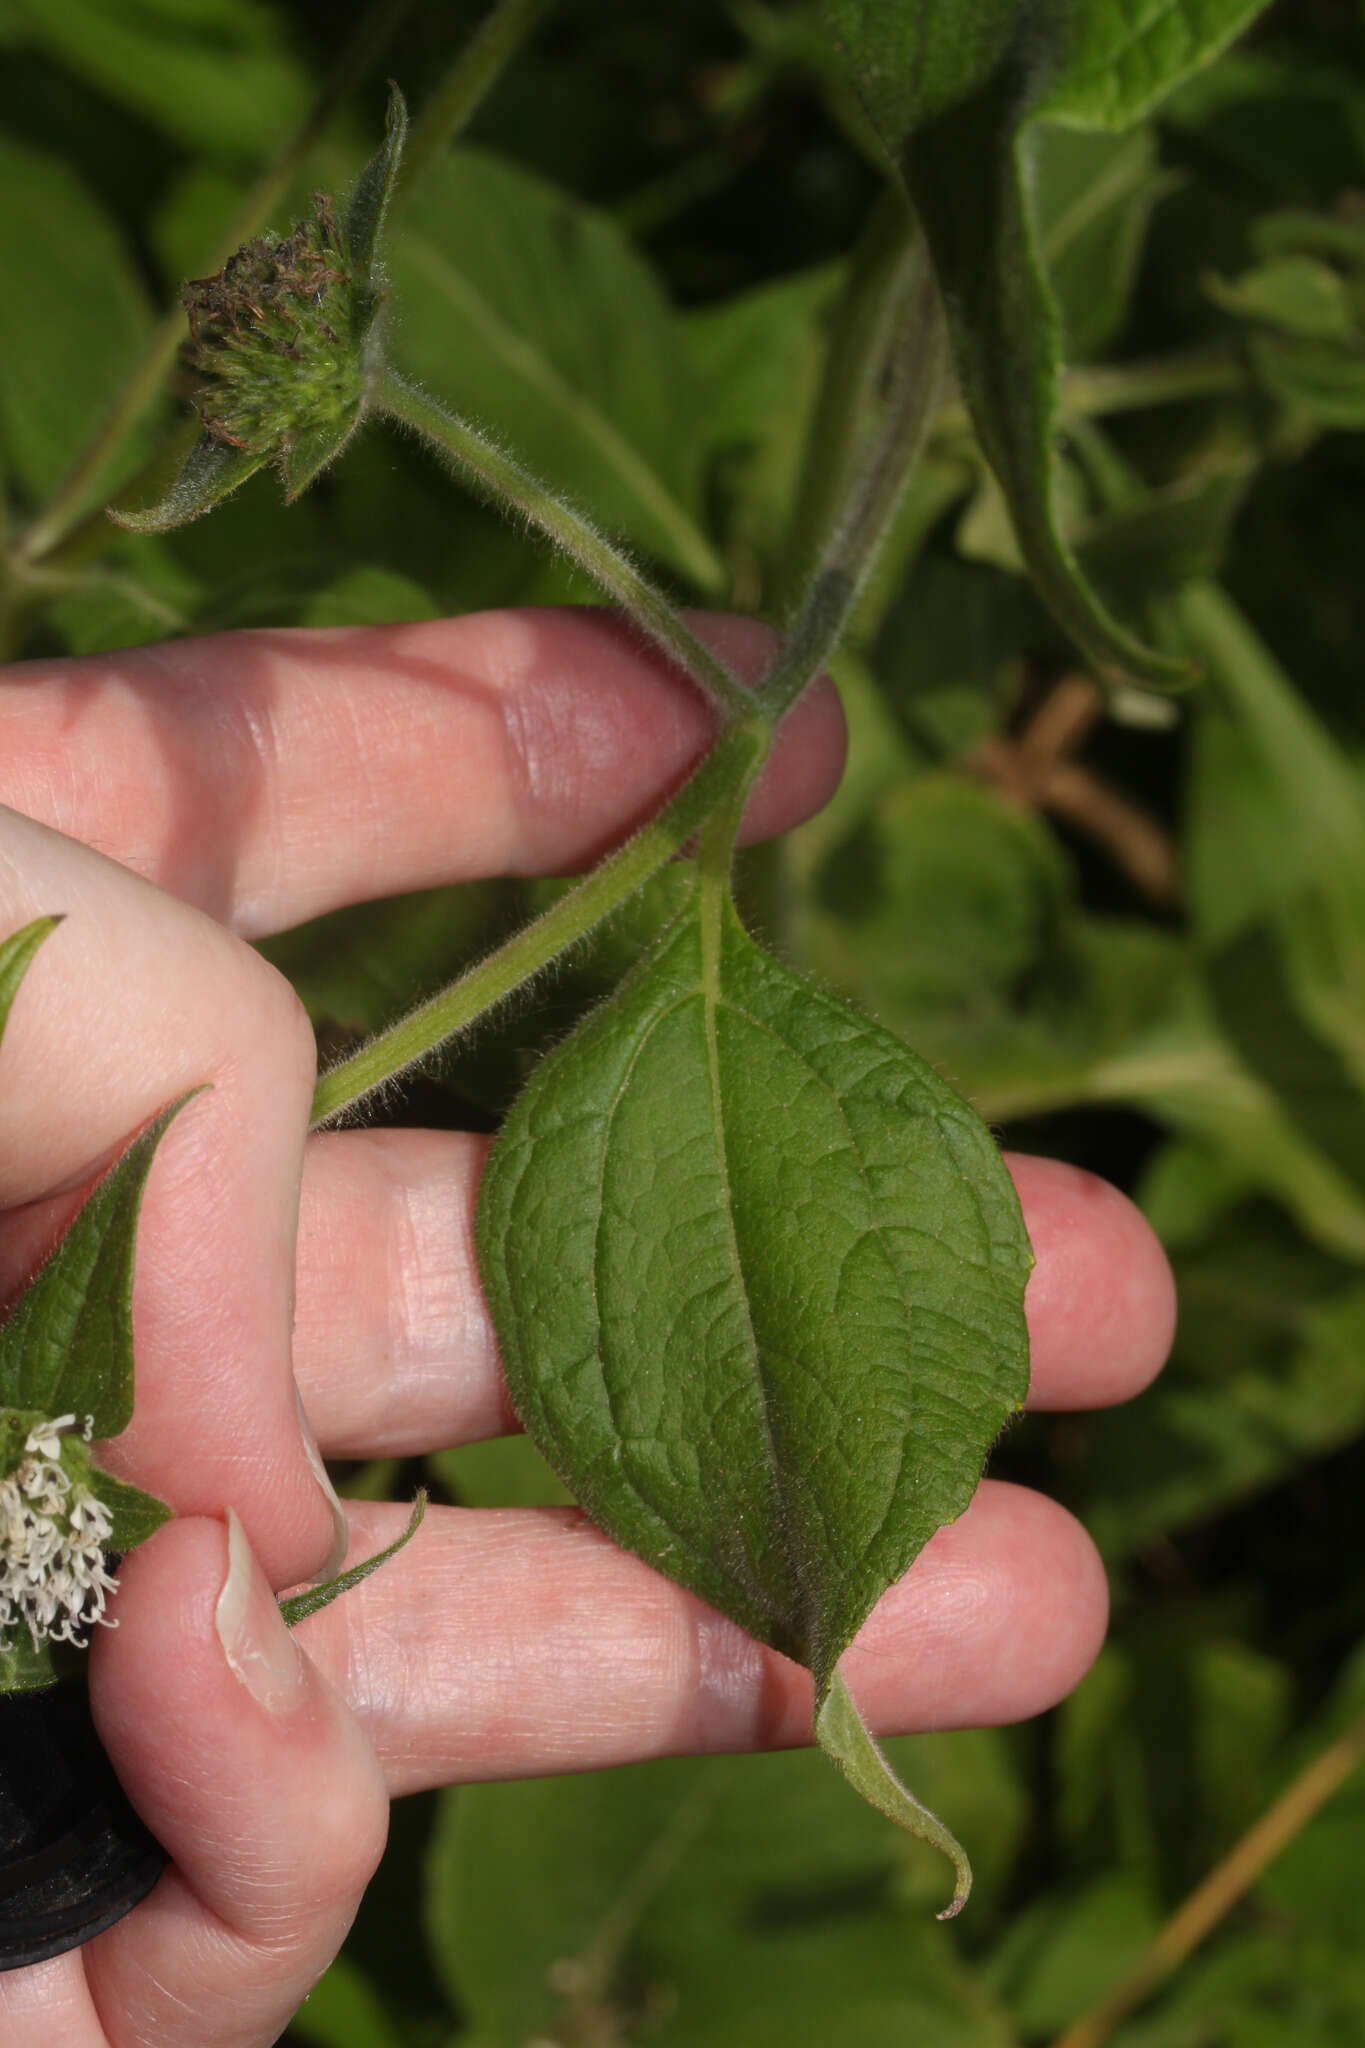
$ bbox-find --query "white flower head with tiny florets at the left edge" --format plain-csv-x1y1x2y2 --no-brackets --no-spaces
0,1415,119,1649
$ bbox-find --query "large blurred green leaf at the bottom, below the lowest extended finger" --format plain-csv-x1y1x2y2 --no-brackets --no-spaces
428,1731,1021,2048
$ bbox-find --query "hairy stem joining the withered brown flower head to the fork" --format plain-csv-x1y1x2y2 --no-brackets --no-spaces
370,369,753,719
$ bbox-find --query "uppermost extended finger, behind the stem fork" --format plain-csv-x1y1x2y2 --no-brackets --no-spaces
0,608,845,938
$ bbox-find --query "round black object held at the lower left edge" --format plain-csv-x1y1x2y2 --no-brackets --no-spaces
0,1677,166,1970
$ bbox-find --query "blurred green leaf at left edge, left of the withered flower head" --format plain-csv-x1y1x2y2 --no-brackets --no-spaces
0,135,151,498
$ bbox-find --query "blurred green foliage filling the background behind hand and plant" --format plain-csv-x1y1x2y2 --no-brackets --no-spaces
0,0,1365,2048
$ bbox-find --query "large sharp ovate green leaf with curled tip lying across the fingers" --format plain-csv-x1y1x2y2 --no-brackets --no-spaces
477,891,1031,1900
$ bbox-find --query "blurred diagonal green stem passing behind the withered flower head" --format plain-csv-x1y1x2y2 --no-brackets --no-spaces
18,0,411,563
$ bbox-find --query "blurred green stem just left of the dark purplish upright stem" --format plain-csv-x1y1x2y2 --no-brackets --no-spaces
780,184,915,602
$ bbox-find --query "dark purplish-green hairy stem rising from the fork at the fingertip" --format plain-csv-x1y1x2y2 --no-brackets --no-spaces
759,244,948,723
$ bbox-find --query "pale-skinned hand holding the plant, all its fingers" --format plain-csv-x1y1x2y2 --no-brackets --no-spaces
0,612,1175,2048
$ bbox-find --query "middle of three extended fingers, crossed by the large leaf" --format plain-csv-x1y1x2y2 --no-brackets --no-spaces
295,1130,1175,1458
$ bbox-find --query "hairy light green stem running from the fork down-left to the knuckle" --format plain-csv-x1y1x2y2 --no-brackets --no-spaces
313,705,772,1128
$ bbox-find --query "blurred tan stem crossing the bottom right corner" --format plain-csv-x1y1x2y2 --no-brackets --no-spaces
1052,1714,1365,2048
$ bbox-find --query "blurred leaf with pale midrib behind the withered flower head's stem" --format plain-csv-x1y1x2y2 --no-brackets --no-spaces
389,147,724,590
